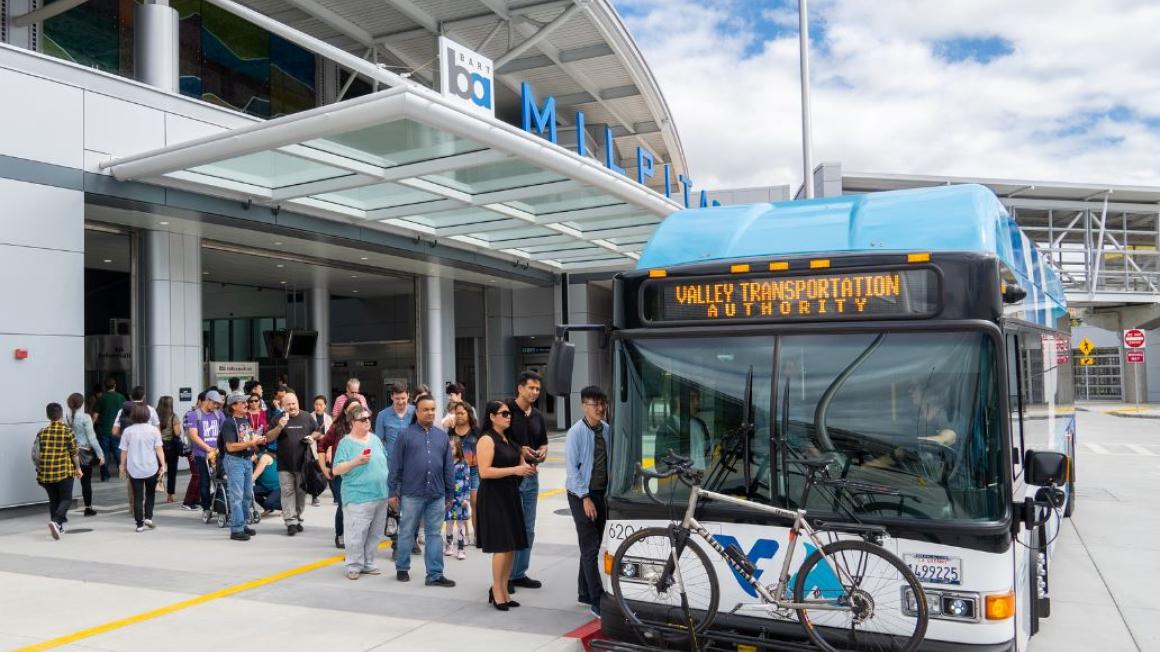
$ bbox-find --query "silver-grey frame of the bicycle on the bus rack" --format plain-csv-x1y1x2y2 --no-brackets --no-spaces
673,485,853,611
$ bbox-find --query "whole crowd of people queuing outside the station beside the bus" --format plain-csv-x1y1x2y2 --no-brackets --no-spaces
32,371,608,616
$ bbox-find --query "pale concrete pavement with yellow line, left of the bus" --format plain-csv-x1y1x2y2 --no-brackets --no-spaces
0,452,592,652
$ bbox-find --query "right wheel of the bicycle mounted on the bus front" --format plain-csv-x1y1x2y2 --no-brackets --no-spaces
793,541,928,652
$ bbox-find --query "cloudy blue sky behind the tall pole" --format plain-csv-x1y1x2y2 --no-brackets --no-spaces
612,0,1160,189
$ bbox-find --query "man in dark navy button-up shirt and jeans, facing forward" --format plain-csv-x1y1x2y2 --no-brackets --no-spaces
384,396,455,587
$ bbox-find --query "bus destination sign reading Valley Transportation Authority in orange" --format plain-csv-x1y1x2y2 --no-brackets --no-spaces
641,268,938,323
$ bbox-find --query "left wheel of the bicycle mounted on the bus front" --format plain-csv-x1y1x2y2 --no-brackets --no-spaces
611,528,720,643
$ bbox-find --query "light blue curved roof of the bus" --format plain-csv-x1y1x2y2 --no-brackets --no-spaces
637,183,1065,305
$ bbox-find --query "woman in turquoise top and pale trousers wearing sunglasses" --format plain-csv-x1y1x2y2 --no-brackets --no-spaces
333,403,386,580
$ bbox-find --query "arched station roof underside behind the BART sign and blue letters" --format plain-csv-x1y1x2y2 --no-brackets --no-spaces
240,0,688,184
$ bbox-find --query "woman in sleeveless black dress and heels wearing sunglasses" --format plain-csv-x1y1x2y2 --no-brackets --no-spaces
476,400,536,611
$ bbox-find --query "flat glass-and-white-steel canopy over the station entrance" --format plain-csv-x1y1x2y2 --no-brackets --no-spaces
102,86,681,271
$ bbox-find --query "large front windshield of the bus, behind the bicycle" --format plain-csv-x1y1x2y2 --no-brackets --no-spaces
610,332,1005,521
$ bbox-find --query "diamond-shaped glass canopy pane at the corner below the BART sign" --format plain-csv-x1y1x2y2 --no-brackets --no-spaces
303,119,486,167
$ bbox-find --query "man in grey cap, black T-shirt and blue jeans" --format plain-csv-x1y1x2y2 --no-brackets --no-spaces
218,392,266,541
